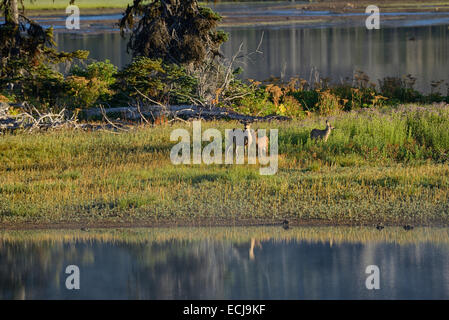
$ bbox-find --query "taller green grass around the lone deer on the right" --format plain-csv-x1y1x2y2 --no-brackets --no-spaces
280,105,449,165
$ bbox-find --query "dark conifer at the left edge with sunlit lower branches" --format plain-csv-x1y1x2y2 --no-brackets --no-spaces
0,0,88,105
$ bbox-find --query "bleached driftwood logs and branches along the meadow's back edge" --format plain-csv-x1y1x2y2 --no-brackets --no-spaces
0,103,290,133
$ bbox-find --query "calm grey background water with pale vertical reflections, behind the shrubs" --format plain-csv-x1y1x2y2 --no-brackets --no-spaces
56,21,449,92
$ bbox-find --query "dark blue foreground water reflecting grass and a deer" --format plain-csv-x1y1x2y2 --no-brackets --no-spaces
0,227,449,299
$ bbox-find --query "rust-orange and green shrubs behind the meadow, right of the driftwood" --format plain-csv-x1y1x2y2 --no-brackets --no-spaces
228,71,449,118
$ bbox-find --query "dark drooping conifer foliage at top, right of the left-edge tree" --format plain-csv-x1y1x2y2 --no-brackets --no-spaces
120,0,227,66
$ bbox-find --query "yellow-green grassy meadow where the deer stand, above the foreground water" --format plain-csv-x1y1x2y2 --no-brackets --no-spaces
0,104,449,228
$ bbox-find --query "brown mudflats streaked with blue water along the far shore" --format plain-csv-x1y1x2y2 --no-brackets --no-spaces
17,1,449,34
